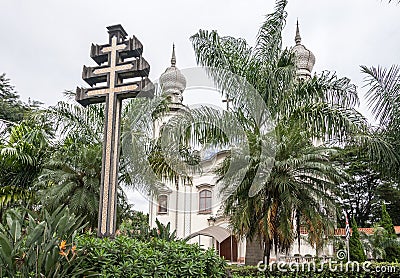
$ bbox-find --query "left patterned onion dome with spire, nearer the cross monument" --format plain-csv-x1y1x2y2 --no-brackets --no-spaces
160,45,186,104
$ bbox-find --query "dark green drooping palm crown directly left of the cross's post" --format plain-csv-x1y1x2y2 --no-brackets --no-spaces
38,138,102,228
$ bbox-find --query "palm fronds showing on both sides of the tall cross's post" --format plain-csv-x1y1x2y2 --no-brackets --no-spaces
37,92,175,228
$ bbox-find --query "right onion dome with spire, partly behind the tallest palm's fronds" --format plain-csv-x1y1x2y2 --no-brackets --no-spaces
293,21,315,79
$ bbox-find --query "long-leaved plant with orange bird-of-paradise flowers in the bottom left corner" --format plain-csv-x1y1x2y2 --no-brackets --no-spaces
0,208,84,277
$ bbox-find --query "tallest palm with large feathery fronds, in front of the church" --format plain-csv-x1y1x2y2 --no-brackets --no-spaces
191,0,368,262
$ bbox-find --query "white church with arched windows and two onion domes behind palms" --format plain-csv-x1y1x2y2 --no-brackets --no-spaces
149,22,334,263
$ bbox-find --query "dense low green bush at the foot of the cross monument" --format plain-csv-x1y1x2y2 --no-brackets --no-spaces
77,235,225,277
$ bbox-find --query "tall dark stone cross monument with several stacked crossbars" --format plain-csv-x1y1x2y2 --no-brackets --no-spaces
76,25,153,237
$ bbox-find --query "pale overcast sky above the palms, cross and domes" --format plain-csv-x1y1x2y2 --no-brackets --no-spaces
0,0,400,211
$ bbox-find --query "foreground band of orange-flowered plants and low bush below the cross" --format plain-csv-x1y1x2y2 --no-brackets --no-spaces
0,207,225,277
